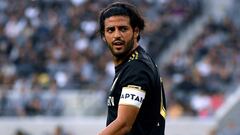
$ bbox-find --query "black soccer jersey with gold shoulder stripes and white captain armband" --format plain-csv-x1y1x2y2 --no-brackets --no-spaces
107,46,166,135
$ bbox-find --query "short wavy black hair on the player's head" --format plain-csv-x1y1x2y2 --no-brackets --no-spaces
99,1,145,41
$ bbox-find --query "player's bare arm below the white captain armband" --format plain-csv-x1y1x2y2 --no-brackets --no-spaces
99,105,139,135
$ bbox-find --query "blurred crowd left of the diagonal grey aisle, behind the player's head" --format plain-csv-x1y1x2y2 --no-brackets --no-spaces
0,0,202,116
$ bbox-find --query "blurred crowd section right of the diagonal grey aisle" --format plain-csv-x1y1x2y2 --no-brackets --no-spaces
162,0,240,118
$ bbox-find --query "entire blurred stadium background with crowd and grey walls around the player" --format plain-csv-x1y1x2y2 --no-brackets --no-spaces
0,0,240,135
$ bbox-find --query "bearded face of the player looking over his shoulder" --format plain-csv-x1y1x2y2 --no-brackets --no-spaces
103,16,139,58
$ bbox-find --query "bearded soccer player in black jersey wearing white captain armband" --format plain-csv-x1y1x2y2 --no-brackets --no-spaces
99,2,166,135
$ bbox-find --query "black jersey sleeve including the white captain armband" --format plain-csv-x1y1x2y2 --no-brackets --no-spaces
119,60,154,108
